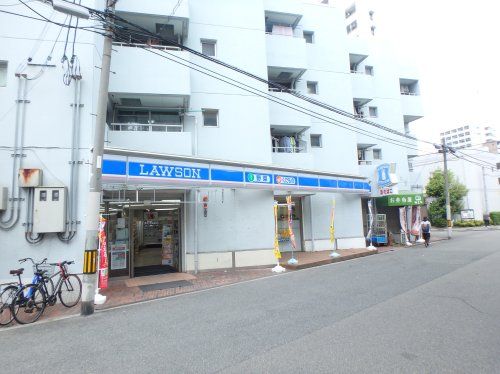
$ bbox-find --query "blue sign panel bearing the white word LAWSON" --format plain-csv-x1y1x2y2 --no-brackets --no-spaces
128,162,210,181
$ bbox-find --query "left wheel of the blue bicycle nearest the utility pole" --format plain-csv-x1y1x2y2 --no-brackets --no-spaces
12,283,47,325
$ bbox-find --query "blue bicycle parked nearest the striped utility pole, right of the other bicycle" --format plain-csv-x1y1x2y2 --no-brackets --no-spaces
11,261,82,324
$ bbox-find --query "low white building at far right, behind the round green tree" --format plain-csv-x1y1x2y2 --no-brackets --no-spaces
411,146,500,220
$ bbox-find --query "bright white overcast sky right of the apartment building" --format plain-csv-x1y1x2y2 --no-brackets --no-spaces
372,0,500,146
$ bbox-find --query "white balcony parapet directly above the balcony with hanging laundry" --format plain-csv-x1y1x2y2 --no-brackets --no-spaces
269,90,311,128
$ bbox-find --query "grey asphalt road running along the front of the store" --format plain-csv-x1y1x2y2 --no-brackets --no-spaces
0,231,500,373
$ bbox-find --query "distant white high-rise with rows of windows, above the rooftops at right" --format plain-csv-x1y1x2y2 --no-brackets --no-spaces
439,125,499,148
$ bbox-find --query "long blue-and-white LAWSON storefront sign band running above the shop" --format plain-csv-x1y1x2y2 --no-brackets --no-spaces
102,155,371,195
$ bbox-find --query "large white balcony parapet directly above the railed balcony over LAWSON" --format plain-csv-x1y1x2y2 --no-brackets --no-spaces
109,43,191,106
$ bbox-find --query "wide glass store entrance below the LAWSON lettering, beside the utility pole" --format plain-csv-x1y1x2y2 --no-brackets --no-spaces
101,190,184,278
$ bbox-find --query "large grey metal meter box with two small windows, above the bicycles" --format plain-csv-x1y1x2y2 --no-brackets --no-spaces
33,187,66,234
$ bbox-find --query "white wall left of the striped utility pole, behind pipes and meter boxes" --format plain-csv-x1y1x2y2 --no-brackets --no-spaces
0,1,101,282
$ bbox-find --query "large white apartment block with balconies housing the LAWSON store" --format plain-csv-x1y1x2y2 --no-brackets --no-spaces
0,0,422,279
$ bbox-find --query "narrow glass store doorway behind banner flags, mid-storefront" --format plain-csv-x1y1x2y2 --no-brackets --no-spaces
274,196,304,252
